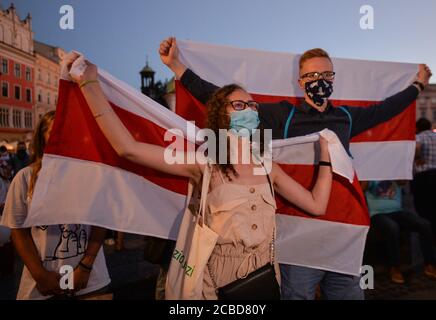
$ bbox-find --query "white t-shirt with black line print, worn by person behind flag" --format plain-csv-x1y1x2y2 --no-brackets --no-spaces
1,167,110,300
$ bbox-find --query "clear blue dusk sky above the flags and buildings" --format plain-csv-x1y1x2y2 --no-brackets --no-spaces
6,0,436,88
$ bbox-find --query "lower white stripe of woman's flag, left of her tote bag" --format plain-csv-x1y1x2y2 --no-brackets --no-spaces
25,154,186,239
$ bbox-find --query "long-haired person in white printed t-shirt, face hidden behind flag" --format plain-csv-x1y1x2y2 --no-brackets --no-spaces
1,111,110,300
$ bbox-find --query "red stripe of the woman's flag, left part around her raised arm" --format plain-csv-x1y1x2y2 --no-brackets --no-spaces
45,80,188,195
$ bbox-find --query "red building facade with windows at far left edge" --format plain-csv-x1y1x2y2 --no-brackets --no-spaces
0,4,35,142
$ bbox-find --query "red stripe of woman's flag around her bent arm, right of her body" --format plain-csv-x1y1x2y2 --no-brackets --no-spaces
276,164,369,226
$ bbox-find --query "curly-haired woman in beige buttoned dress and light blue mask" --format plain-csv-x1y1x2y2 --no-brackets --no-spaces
68,52,332,299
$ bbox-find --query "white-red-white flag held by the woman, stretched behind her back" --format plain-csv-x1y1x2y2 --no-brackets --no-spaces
26,44,416,274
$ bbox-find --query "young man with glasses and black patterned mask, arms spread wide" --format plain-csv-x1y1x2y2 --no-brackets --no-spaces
159,38,431,299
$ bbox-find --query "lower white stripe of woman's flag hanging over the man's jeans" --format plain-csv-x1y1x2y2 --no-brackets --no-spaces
276,214,369,276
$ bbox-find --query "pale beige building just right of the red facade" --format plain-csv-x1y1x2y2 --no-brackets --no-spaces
34,40,65,121
